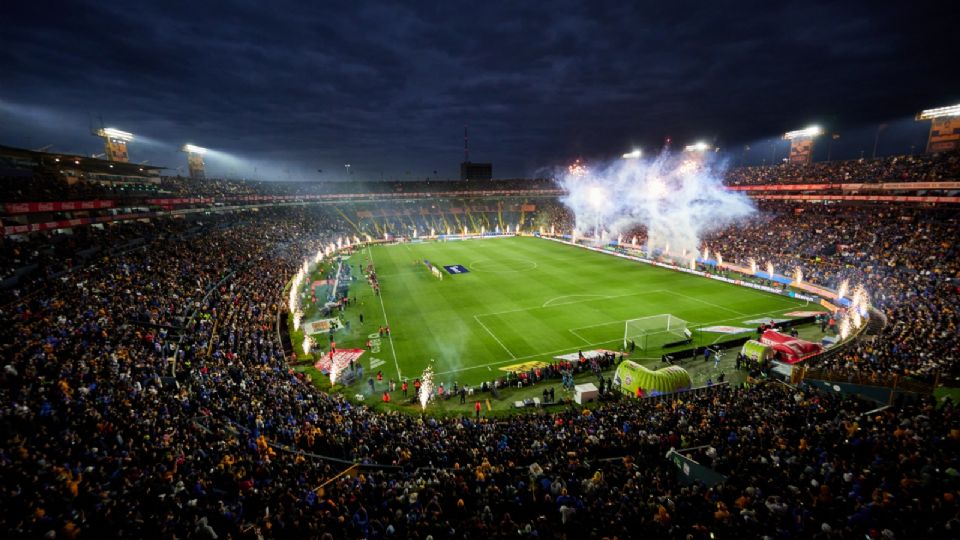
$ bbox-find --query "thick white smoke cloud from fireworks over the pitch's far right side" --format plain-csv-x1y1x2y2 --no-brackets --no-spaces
560,153,756,258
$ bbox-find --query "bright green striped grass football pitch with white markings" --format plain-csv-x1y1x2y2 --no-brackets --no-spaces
341,237,820,384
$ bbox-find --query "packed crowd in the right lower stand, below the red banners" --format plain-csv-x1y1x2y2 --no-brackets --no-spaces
705,205,960,382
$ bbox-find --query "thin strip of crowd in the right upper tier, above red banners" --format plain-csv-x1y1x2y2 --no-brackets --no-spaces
725,152,960,186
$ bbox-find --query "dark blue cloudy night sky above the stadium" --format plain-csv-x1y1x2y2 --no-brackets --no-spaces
0,0,960,180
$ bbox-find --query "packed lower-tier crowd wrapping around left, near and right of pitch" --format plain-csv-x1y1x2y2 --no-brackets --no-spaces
0,195,960,539
